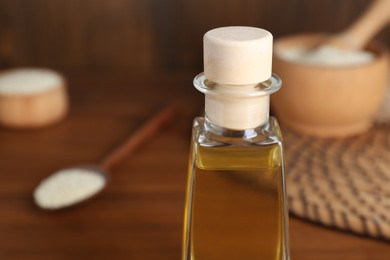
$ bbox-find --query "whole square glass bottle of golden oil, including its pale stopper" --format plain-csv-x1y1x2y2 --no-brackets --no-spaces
183,27,289,260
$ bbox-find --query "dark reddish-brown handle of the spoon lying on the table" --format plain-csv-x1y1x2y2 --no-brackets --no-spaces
100,101,181,172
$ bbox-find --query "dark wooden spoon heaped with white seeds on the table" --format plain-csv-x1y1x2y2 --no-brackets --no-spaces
34,101,180,210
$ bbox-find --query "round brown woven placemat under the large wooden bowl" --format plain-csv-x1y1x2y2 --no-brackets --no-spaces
282,124,390,240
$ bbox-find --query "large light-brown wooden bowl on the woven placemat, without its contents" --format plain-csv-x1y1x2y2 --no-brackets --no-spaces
271,35,389,137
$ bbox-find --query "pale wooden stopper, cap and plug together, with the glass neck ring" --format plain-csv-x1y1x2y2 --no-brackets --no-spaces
198,26,280,130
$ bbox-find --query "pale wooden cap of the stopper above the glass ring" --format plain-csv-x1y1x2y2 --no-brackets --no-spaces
203,26,272,85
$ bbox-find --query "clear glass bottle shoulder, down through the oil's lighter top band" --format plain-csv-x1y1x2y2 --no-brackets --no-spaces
191,118,283,170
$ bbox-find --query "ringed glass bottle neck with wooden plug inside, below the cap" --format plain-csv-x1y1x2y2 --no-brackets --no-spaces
194,73,282,132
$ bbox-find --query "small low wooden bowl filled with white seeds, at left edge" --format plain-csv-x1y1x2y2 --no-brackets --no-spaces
0,68,68,129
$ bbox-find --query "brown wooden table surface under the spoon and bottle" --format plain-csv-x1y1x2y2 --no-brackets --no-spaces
0,73,390,260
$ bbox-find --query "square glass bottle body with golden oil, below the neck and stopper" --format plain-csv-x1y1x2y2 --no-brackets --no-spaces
183,117,289,260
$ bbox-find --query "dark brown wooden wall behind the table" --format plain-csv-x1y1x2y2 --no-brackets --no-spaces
0,0,390,74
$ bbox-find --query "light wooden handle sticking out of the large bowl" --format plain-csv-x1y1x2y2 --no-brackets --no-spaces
326,0,390,50
